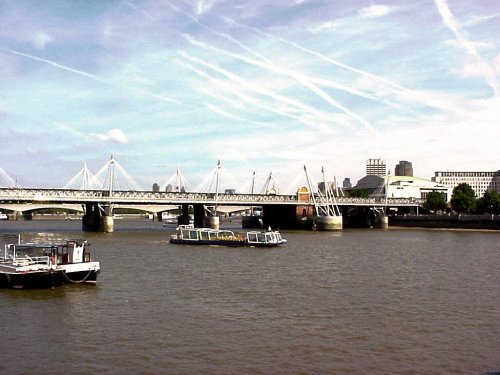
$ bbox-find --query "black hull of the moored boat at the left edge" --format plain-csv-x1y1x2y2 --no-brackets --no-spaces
0,270,99,289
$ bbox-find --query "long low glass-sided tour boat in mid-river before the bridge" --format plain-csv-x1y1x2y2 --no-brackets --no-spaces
170,224,286,247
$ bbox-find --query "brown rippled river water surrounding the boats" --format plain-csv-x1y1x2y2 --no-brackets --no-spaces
0,220,500,375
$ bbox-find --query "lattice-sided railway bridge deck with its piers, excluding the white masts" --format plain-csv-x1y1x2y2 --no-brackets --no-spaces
0,187,423,232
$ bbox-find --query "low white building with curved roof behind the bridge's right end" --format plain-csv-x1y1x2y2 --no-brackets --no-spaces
356,176,453,202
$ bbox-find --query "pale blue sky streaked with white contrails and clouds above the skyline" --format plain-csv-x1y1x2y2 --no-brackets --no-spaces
0,0,500,192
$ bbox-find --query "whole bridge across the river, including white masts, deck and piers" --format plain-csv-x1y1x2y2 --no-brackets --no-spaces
0,157,423,232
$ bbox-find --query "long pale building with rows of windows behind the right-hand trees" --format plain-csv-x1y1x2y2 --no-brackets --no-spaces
432,170,500,198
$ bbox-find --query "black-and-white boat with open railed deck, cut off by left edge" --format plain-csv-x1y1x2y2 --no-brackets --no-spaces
0,241,100,289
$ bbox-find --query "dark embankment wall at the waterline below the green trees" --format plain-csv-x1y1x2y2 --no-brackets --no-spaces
389,215,500,230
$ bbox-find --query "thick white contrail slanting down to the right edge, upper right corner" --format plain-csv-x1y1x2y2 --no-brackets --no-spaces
434,0,499,97
